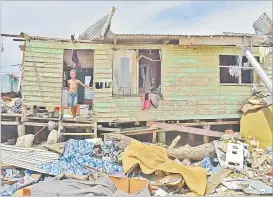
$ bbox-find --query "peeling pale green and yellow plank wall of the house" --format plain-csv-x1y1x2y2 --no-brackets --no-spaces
22,41,272,122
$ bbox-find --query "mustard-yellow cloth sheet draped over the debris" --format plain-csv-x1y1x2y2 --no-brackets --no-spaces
122,141,207,195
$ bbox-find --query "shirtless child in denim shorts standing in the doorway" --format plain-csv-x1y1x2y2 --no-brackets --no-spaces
67,70,92,119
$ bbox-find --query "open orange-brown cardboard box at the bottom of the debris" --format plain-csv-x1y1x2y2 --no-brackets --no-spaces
109,176,148,194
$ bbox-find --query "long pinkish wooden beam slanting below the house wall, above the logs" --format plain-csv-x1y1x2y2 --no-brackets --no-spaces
146,122,223,137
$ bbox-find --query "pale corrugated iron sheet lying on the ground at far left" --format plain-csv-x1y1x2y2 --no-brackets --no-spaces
1,144,59,175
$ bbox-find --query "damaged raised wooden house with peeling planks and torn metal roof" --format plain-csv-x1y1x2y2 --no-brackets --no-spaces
7,7,272,139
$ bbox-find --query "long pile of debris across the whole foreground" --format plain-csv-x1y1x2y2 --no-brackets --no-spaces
1,129,273,196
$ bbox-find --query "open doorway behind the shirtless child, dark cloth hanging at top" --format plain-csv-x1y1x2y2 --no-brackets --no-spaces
62,49,94,119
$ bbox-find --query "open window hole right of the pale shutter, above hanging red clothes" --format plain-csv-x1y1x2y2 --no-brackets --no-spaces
138,50,161,94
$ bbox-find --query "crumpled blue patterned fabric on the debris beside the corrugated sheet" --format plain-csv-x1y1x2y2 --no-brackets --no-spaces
41,139,123,175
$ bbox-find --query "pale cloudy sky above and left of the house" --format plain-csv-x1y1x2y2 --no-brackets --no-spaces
1,1,272,72
